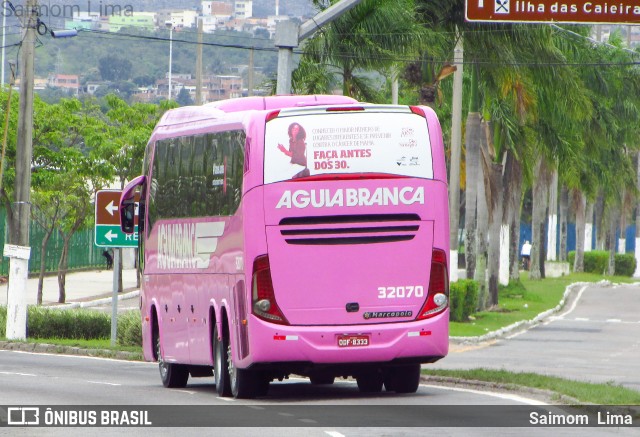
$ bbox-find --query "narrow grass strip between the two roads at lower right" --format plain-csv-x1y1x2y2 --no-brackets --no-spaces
422,369,640,405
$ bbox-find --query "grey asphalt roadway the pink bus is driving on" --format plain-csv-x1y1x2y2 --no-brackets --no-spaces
0,351,634,437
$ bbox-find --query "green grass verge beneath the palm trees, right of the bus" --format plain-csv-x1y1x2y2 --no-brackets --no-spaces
449,272,636,337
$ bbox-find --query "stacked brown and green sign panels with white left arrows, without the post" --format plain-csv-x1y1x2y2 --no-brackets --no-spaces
94,190,140,247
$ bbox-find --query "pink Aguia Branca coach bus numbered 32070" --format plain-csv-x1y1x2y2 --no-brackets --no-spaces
120,96,449,398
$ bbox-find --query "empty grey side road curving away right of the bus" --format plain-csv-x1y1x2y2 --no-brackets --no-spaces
433,284,640,390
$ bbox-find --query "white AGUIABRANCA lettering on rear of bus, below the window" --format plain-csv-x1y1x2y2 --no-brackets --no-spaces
276,187,424,209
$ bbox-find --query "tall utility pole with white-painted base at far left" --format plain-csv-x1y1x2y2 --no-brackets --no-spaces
5,0,38,340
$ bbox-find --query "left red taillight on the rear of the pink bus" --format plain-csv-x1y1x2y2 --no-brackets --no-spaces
251,255,289,325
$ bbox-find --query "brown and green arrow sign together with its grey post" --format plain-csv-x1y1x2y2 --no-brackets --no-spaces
94,190,140,346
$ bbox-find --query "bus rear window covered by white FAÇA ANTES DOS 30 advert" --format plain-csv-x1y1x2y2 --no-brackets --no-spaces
264,111,433,184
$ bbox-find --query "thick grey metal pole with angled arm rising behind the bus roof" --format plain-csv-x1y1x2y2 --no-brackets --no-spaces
275,0,362,95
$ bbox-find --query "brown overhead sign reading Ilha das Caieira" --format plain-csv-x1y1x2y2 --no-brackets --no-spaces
466,0,640,24
